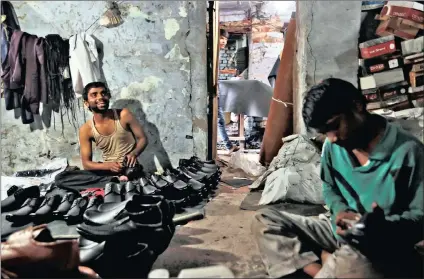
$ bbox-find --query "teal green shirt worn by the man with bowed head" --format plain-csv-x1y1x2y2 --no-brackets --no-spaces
321,116,424,241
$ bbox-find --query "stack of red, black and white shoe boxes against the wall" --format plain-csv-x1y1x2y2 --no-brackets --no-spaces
359,1,424,110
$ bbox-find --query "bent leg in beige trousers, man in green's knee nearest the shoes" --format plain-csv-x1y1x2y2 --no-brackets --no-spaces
252,207,337,278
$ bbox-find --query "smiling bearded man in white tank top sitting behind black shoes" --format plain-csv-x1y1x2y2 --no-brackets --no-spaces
79,82,147,174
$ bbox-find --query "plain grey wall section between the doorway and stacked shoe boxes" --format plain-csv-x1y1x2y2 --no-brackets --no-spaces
294,1,361,133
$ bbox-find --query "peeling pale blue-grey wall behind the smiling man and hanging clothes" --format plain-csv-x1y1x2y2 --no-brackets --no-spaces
1,1,207,174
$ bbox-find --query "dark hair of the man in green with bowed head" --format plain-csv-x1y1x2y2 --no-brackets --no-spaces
302,78,366,129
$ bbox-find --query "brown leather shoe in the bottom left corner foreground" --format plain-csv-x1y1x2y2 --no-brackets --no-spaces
1,225,95,278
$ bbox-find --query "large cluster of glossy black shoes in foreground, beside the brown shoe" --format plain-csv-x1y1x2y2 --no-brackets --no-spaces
77,195,175,277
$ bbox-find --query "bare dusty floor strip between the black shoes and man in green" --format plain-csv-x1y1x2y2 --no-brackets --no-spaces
153,163,266,278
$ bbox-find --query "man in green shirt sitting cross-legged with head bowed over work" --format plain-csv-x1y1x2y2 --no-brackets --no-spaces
252,78,424,278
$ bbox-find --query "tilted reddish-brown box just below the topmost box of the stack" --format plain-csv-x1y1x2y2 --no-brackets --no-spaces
375,17,420,40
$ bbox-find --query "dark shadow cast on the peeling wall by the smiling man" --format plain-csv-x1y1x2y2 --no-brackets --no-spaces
112,99,172,172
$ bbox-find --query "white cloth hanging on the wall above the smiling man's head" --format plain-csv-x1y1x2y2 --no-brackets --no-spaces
69,33,101,97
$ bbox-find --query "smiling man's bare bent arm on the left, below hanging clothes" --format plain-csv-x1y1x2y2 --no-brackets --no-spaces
79,124,109,170
